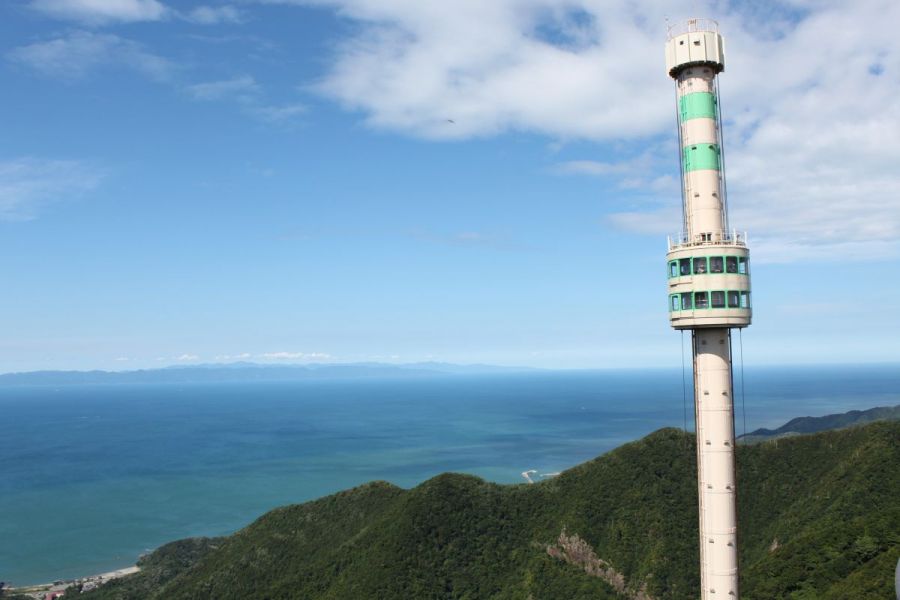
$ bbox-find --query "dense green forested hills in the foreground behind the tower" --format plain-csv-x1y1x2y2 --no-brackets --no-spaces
79,421,900,600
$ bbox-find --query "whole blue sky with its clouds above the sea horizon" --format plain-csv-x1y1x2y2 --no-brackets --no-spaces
0,0,900,371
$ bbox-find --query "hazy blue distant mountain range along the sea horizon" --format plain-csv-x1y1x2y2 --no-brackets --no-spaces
0,362,537,386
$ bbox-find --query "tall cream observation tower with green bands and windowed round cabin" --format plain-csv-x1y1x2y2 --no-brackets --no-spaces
666,19,751,599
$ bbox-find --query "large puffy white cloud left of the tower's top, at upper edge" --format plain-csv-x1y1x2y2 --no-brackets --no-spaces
284,0,674,139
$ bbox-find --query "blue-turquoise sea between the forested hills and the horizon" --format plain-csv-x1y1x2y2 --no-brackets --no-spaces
0,366,900,585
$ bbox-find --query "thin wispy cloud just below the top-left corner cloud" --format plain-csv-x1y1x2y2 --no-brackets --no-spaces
7,31,173,81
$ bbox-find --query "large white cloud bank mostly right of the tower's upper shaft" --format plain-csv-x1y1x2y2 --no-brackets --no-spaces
592,1,900,262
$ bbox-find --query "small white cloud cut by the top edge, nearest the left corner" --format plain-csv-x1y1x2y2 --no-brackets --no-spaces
29,0,170,25
